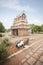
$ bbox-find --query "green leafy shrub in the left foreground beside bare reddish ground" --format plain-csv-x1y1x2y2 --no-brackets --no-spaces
0,38,9,61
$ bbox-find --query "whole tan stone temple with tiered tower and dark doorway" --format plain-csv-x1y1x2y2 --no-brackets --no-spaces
11,13,29,36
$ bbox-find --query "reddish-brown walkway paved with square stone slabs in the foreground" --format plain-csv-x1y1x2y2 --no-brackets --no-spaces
3,37,43,65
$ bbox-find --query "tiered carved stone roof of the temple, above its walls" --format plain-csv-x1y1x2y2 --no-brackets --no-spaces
11,13,29,29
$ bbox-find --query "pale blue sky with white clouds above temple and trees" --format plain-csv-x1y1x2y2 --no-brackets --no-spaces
0,0,43,29
